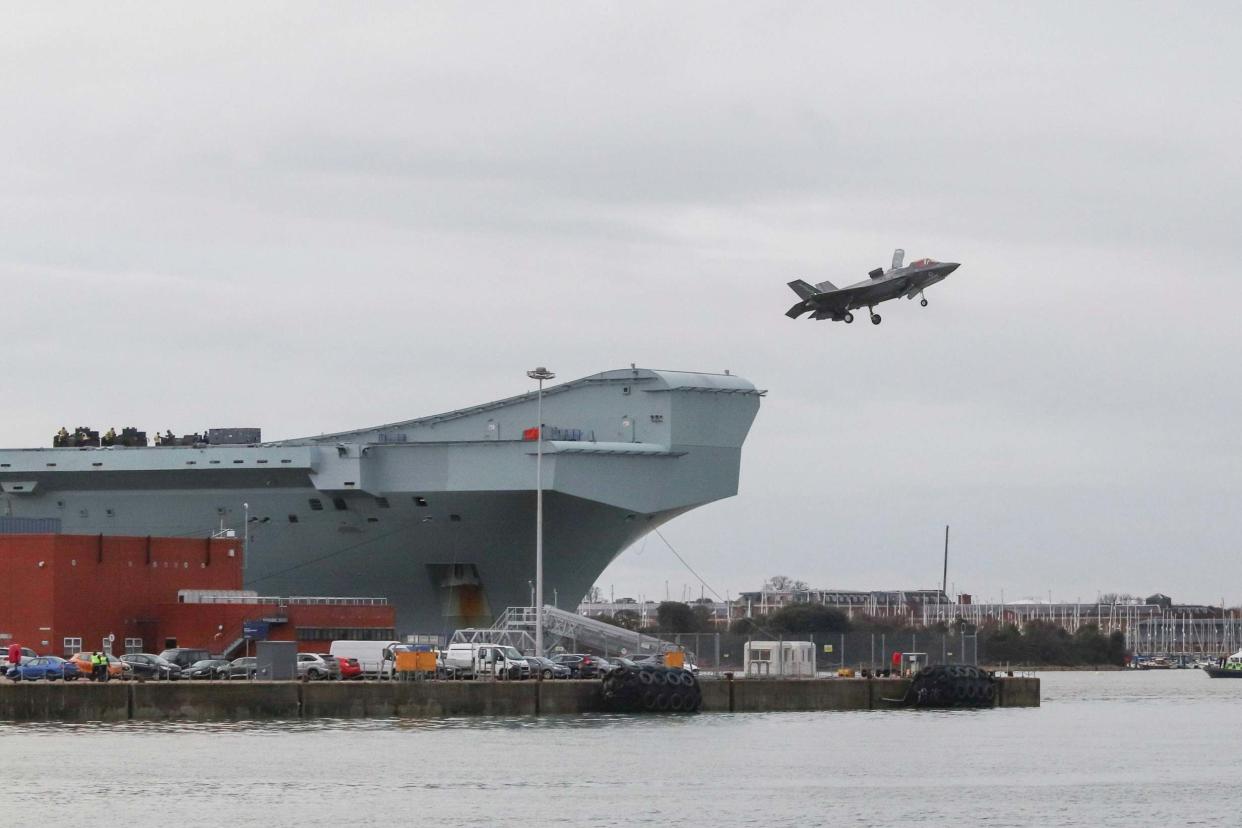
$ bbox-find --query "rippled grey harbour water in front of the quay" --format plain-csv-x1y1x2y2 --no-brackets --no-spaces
0,670,1242,826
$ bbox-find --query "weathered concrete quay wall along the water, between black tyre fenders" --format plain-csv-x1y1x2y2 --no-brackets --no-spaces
0,678,1040,721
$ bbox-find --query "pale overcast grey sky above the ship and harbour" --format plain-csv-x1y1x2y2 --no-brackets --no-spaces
7,2,1242,603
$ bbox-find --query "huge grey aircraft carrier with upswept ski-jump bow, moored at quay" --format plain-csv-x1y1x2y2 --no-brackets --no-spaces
0,369,763,634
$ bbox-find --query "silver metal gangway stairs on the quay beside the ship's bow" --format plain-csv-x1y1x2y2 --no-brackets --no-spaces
452,606,679,657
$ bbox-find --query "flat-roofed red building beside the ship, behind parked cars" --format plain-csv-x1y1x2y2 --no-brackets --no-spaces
0,535,395,655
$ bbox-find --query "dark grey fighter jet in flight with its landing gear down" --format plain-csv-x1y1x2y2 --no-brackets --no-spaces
785,250,960,325
